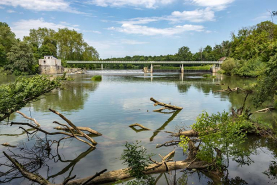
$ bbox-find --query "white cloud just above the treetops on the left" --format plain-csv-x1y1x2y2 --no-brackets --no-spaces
11,18,79,39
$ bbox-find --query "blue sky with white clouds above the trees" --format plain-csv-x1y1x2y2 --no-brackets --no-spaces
0,0,277,59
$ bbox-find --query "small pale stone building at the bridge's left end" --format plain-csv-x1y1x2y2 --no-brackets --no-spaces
39,56,64,74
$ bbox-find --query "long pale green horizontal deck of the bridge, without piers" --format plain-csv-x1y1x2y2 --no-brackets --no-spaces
67,61,223,64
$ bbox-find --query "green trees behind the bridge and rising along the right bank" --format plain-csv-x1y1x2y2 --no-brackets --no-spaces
102,21,277,74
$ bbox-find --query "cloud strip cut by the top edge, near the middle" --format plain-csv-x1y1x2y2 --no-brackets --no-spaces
88,0,175,8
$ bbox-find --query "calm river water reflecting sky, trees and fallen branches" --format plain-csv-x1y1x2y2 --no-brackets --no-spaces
0,70,277,185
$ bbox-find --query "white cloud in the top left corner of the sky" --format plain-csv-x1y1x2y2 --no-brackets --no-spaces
0,0,84,14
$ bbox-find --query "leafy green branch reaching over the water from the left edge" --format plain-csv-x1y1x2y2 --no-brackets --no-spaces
0,75,60,121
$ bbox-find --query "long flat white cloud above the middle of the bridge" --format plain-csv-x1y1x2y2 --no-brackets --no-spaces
109,24,204,36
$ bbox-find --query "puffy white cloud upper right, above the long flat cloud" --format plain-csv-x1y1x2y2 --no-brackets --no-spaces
167,8,214,22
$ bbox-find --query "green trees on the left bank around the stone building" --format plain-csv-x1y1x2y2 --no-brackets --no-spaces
0,22,99,75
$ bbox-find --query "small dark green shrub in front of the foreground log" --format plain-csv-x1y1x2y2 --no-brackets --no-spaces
121,141,154,185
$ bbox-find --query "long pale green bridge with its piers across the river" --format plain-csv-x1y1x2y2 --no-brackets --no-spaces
67,60,223,73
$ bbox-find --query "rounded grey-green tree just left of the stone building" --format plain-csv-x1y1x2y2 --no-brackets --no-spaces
5,42,38,75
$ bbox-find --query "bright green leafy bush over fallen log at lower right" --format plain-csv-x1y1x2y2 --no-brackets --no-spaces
192,112,249,164
